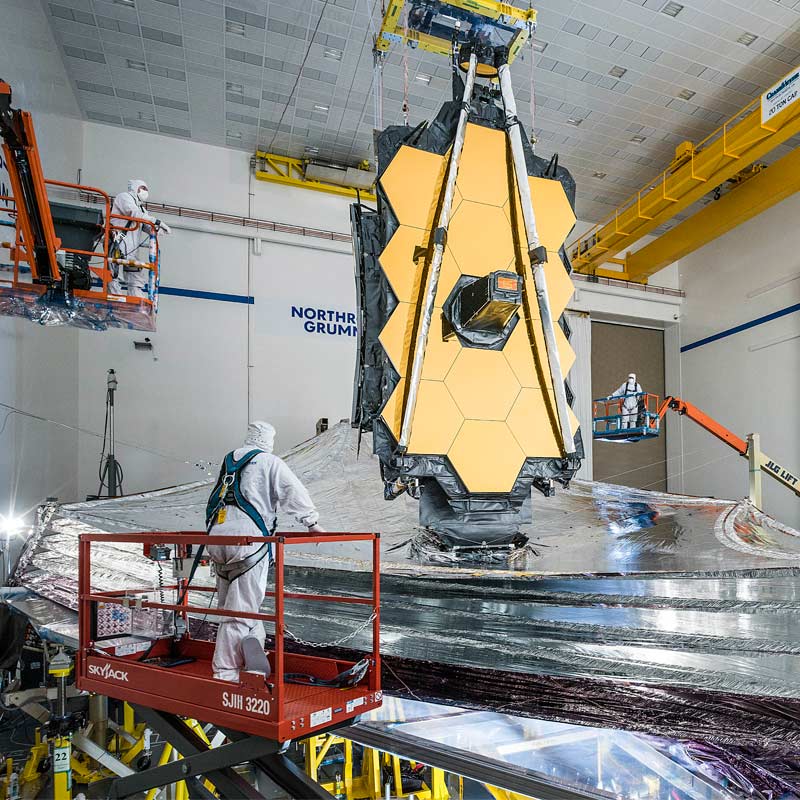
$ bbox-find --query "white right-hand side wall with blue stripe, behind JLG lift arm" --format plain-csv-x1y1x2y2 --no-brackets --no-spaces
676,195,800,527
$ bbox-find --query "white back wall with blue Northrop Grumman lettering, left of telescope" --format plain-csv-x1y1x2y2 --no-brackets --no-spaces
73,123,356,494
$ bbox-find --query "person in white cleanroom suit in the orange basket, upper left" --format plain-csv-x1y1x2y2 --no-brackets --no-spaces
108,178,171,297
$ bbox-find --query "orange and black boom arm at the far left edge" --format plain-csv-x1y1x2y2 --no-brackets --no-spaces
0,80,61,285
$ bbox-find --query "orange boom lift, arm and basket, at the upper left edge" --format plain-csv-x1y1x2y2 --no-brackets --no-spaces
0,80,159,330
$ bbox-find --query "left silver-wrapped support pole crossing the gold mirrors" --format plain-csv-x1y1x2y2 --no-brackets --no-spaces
397,53,478,453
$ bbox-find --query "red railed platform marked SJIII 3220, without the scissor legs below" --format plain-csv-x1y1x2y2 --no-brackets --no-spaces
76,532,382,742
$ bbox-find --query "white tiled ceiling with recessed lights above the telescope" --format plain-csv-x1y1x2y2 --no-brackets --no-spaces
39,0,800,220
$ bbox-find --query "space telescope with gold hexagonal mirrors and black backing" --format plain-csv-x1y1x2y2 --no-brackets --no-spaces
351,3,583,548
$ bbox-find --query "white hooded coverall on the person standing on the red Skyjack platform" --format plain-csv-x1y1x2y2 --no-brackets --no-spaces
208,422,319,681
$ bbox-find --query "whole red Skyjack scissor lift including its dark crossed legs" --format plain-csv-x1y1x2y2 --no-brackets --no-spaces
76,532,382,798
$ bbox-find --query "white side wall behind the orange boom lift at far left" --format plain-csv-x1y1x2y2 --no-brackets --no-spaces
0,0,83,544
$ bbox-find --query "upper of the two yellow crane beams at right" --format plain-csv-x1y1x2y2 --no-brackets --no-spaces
567,69,800,283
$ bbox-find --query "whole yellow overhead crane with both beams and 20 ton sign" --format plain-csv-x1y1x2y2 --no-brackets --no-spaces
567,70,800,283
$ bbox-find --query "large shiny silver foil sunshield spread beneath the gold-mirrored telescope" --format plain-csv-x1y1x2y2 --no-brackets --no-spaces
9,424,800,780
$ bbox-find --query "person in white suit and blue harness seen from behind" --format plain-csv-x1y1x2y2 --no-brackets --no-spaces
206,422,325,681
